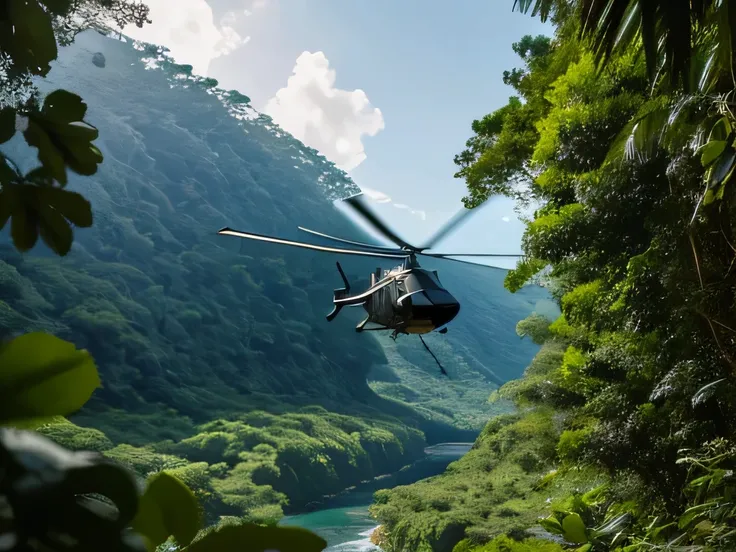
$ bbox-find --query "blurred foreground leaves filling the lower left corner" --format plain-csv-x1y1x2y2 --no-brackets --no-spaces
0,333,326,552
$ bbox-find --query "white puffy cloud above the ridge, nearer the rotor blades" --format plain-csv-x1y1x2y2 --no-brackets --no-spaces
263,52,384,171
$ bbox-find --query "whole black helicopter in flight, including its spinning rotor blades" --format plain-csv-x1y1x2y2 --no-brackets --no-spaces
218,193,521,340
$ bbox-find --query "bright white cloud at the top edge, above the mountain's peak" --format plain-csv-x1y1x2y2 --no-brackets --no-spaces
124,0,250,76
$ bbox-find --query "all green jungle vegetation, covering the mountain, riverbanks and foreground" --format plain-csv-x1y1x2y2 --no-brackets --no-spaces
7,0,736,552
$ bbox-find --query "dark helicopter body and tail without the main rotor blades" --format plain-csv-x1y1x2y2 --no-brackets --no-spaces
327,256,460,335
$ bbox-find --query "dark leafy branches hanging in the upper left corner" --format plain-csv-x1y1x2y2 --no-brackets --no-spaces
0,0,150,255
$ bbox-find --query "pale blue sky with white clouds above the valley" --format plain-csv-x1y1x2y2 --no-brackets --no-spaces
124,0,552,268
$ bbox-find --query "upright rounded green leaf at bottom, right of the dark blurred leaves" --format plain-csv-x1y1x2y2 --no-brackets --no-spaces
132,472,202,548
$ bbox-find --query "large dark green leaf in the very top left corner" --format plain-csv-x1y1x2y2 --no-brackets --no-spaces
5,0,58,76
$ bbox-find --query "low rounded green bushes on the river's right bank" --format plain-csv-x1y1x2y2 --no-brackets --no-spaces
371,410,598,552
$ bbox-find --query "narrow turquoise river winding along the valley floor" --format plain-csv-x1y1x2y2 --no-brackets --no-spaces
281,443,473,552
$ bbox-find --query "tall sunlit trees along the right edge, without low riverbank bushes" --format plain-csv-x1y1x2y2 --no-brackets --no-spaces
446,0,736,550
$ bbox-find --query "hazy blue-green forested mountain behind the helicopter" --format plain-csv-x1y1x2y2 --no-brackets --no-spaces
0,32,546,517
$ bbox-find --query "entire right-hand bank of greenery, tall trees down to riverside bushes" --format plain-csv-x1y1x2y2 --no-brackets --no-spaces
373,0,736,552
